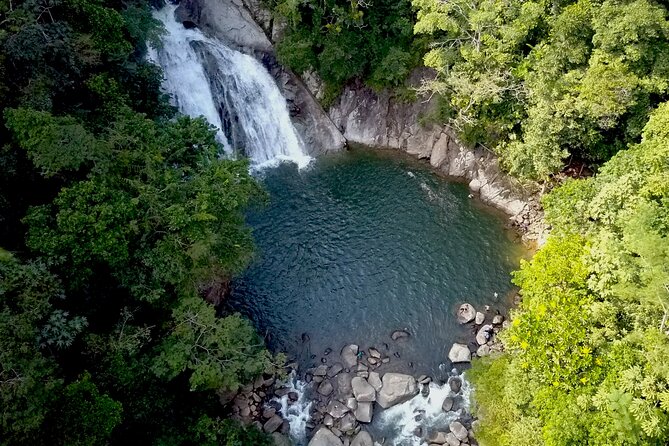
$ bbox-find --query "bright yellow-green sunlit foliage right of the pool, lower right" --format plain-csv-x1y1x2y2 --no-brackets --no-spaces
472,102,669,445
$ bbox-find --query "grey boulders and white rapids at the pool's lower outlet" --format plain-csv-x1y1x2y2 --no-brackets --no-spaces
230,303,507,446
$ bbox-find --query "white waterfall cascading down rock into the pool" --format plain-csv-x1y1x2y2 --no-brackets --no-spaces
149,5,311,169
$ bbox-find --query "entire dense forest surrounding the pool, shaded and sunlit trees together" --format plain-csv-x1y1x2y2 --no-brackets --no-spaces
0,0,669,446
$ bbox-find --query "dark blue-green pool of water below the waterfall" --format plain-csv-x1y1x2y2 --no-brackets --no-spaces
228,150,524,376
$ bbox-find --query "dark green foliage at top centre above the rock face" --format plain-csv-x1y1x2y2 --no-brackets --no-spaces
270,0,423,98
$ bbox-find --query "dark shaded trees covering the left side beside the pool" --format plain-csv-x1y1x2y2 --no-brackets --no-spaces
0,0,274,445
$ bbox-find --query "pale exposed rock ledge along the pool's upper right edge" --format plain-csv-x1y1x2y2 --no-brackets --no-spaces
326,80,545,244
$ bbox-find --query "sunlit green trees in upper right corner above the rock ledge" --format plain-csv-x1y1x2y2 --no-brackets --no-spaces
413,0,669,179
